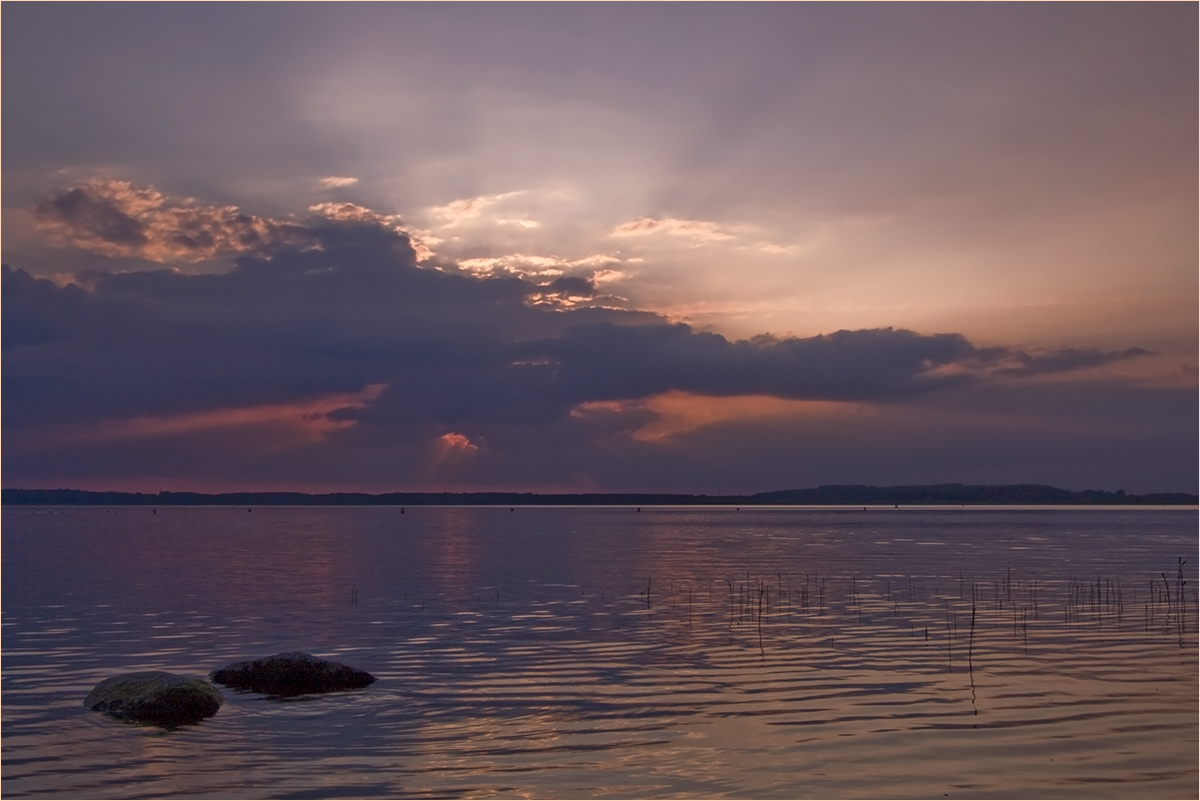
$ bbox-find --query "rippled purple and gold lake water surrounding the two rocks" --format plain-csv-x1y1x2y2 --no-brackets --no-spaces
0,507,1198,799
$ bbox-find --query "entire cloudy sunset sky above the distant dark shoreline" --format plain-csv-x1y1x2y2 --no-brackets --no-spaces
0,2,1200,494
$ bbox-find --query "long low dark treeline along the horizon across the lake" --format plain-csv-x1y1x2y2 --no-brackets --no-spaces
0,484,1200,506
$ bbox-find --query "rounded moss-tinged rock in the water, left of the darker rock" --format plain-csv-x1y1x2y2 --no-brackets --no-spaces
83,670,224,725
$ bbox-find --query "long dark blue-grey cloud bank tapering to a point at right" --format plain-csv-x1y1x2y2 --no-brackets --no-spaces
4,221,1140,423
